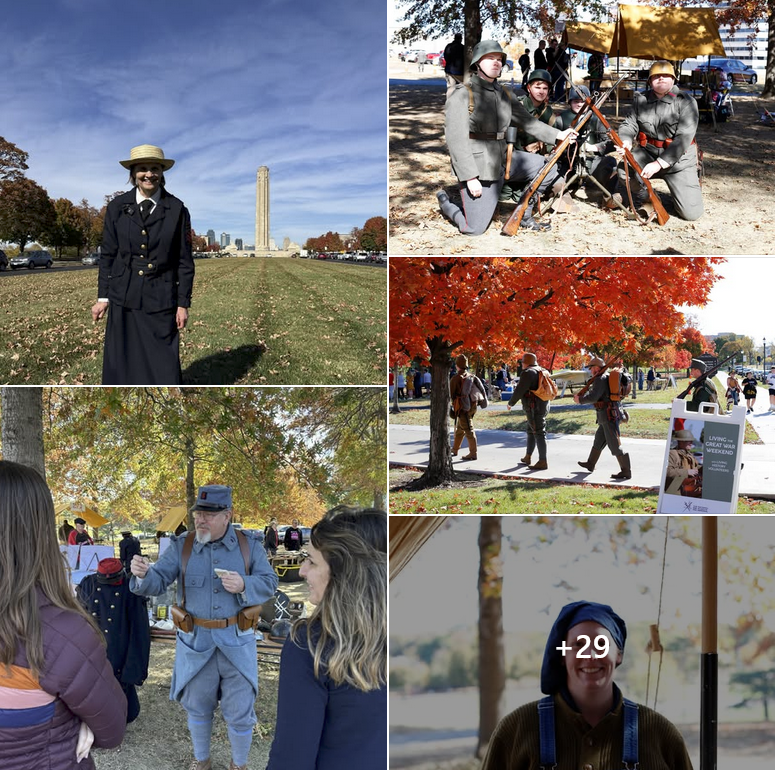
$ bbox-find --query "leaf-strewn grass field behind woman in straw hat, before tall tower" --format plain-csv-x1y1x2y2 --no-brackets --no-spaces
0,258,387,385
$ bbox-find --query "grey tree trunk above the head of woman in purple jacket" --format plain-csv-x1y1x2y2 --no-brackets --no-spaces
0,388,46,479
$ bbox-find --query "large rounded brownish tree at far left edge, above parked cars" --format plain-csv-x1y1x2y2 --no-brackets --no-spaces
0,177,56,252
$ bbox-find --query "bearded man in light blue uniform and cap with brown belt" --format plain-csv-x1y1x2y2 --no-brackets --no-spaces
129,485,277,770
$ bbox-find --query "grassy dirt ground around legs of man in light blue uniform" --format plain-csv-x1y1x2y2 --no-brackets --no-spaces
92,583,312,770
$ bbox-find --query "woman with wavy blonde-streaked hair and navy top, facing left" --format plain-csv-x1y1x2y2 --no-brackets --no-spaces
267,506,387,770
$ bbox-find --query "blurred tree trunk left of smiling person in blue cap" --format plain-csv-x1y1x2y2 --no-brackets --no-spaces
476,516,506,758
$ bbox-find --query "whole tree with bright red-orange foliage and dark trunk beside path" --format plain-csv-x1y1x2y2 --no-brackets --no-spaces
390,257,723,487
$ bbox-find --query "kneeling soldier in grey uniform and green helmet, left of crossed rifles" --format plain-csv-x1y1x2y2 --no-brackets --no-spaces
436,40,575,235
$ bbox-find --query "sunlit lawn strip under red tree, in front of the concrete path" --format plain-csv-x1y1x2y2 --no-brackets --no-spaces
389,469,775,516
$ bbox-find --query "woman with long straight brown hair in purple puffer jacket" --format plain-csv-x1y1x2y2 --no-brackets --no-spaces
0,461,126,770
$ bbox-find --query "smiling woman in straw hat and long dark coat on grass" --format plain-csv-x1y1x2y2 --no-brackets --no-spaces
92,144,194,385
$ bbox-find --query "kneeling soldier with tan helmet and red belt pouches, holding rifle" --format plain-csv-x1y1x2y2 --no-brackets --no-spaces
619,61,703,220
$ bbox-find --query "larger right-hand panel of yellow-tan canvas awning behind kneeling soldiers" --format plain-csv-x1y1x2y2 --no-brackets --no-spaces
609,5,726,61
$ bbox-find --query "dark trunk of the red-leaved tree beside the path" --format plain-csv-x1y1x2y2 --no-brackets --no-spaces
411,337,455,489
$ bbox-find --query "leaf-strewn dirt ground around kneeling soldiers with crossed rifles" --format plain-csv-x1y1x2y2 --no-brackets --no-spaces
389,60,775,255
